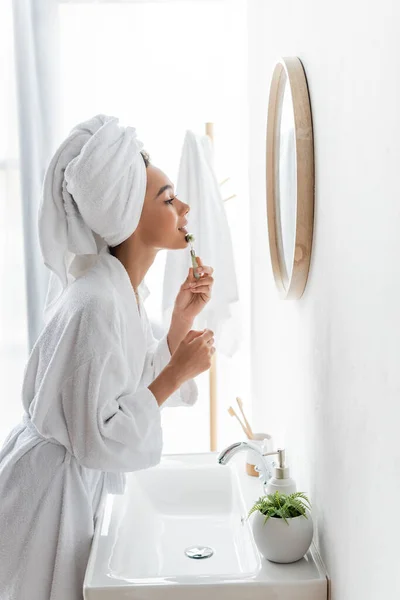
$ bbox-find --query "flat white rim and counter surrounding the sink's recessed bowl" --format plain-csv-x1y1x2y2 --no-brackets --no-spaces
84,452,328,600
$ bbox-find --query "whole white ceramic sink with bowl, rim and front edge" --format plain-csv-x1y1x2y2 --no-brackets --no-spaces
84,453,326,600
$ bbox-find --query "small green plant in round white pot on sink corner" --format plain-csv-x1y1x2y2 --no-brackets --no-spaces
248,491,313,563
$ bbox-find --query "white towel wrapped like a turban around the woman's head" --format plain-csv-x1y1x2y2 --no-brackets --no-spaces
39,114,147,321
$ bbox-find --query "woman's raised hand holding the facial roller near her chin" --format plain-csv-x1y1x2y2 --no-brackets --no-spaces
174,256,214,322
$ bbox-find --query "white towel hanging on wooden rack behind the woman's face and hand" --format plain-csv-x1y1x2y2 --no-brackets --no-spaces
162,130,241,356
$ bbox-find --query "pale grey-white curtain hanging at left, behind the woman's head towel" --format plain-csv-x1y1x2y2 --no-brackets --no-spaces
13,0,60,349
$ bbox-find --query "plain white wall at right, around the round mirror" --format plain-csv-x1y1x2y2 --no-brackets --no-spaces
248,0,400,600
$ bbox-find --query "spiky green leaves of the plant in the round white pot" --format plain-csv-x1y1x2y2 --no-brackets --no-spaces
248,491,311,525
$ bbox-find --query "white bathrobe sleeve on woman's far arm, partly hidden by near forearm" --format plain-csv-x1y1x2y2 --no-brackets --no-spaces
144,314,198,409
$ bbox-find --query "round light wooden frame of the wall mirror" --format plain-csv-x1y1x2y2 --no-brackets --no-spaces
266,57,315,300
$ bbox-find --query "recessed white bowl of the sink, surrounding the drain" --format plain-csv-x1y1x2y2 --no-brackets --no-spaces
109,457,261,583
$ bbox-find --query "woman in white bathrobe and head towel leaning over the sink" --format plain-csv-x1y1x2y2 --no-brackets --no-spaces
0,115,215,600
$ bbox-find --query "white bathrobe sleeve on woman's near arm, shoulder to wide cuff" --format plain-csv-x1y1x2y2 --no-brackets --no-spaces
29,294,163,472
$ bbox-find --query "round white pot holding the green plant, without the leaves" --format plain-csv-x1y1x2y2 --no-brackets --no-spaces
253,510,314,563
